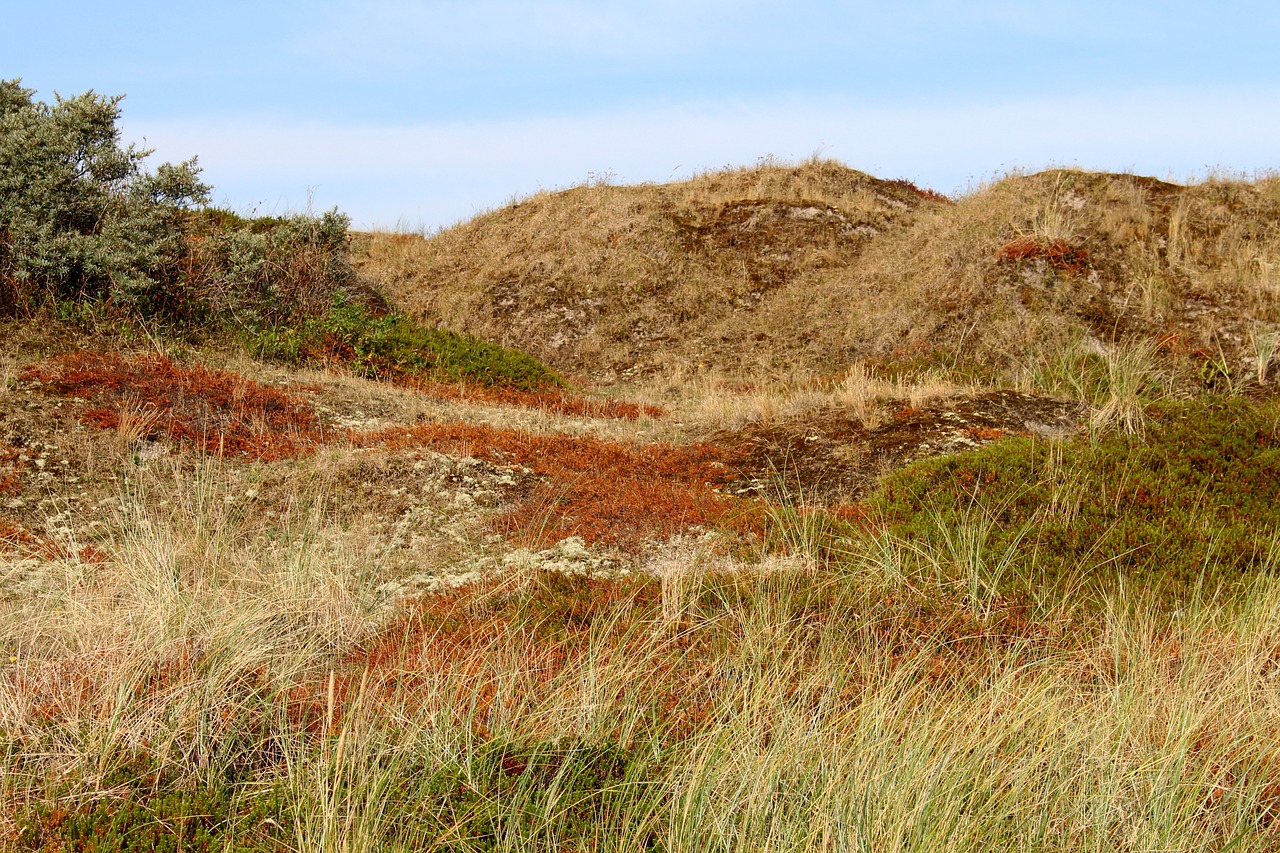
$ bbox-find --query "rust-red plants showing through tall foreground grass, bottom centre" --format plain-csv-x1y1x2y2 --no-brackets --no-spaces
287,573,732,740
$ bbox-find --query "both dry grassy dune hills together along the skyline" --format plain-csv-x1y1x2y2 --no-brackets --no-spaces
362,161,1280,380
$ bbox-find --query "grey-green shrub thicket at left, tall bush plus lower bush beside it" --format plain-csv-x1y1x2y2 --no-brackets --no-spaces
0,79,360,327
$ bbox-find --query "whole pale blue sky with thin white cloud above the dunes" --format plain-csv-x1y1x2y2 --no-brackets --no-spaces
0,0,1280,232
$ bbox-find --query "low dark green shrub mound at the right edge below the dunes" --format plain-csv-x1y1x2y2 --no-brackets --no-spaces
870,398,1280,599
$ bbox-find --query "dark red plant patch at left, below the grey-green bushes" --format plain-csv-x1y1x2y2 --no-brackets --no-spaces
23,351,326,461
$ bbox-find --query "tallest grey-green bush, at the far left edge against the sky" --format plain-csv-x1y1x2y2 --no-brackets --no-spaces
0,79,209,313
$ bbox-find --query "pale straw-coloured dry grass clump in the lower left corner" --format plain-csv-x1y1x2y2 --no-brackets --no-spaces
0,460,376,849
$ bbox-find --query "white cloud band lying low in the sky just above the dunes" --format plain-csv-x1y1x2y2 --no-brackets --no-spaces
127,91,1280,227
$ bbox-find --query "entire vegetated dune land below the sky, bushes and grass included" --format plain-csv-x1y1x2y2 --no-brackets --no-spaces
12,81,1280,853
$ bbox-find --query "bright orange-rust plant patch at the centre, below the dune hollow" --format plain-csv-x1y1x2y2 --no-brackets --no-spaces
352,423,745,546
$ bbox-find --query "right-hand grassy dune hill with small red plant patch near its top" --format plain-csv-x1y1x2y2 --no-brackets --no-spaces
832,170,1280,378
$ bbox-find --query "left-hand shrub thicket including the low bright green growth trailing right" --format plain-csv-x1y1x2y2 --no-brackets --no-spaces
0,79,561,389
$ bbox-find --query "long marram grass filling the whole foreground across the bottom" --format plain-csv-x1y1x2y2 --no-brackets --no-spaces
0,450,1280,850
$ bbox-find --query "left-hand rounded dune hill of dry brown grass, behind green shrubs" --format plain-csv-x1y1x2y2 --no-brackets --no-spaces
355,161,945,373
